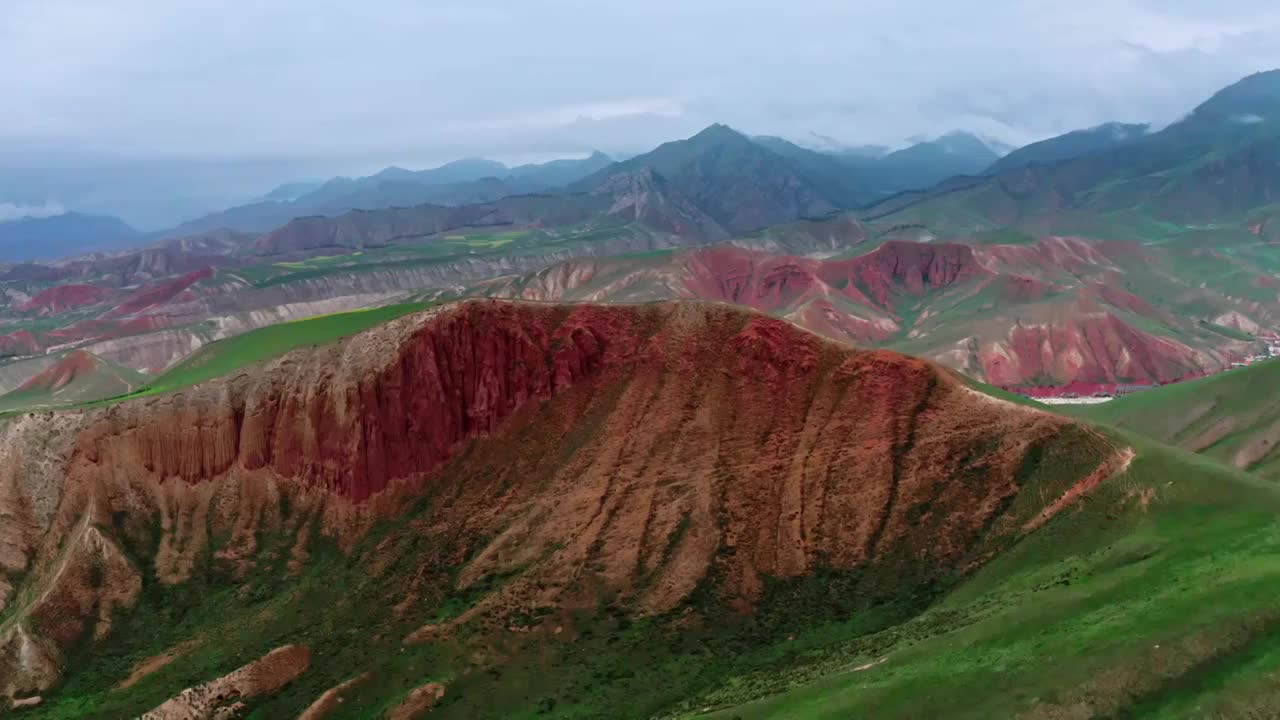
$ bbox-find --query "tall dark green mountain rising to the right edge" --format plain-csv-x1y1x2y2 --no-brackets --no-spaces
863,70,1280,233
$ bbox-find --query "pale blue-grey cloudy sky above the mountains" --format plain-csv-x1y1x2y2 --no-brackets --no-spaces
0,0,1280,225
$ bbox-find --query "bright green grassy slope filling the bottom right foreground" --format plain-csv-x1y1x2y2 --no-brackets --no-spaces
716,427,1280,720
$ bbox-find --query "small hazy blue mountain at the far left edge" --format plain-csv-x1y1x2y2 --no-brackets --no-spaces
0,213,141,261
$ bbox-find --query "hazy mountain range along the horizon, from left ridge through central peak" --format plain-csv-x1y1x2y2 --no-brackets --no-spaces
168,124,997,234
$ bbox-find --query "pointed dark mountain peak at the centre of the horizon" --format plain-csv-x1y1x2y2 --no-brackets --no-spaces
586,124,859,233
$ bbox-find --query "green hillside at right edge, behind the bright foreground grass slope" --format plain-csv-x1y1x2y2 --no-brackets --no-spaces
1070,360,1280,477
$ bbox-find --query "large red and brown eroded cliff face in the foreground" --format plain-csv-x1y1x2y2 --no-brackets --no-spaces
0,301,1114,696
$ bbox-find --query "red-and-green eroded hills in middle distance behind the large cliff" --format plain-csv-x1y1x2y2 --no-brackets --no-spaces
466,237,1259,392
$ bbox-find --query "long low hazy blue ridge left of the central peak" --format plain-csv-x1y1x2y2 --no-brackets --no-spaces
165,152,612,236
